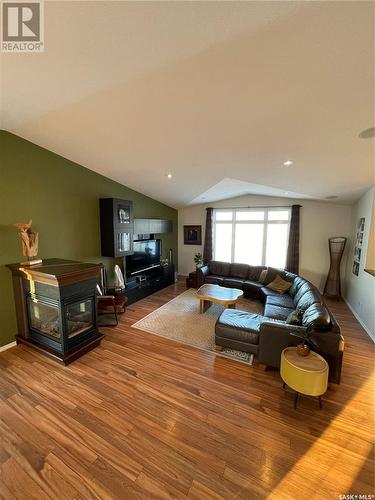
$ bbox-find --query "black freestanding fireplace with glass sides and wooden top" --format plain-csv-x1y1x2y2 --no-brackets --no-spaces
8,259,103,364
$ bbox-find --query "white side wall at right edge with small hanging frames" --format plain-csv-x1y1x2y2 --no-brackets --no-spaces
344,188,375,341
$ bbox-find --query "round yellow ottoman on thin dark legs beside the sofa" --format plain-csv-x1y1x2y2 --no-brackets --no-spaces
280,347,328,408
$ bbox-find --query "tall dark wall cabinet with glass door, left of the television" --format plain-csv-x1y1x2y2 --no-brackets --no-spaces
100,198,134,257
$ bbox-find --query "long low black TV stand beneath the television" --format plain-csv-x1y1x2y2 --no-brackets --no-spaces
115,264,175,304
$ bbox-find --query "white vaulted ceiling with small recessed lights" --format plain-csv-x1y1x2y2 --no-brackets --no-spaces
0,1,375,207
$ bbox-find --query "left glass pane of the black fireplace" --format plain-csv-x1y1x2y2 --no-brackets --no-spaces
27,297,61,340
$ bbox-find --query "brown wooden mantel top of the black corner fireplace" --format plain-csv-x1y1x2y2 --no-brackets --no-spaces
7,259,100,286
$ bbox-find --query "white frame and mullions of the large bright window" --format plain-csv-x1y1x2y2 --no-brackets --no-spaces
212,206,291,266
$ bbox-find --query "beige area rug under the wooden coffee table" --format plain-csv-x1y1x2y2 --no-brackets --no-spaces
132,288,262,364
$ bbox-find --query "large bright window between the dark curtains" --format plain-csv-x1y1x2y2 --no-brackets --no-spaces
214,207,290,268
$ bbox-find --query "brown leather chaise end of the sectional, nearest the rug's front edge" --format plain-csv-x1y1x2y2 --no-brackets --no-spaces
215,309,263,344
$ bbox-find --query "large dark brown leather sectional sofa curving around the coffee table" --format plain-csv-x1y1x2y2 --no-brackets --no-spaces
198,261,344,384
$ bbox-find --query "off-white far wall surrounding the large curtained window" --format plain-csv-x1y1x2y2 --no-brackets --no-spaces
178,195,352,290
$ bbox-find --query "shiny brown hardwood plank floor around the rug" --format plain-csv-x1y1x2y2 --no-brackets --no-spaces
0,283,374,499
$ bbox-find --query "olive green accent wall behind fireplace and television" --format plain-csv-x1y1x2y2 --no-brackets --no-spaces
0,130,177,346
